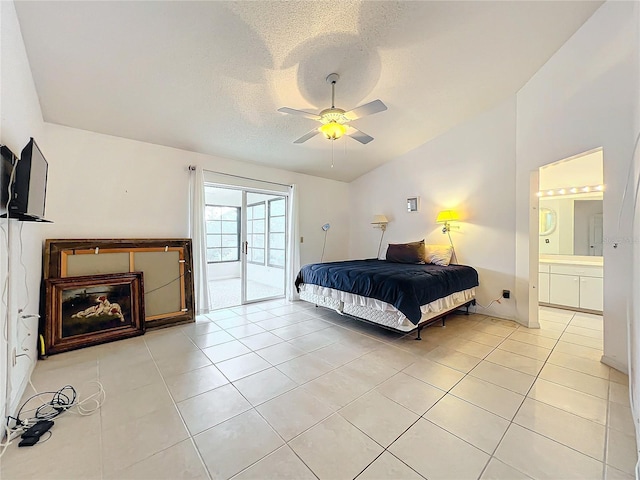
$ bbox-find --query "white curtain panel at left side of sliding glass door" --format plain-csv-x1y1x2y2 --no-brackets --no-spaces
189,167,209,315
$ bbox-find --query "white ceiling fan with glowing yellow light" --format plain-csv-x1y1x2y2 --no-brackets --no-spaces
278,73,387,145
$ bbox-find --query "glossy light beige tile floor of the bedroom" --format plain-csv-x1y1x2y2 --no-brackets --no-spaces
0,301,636,480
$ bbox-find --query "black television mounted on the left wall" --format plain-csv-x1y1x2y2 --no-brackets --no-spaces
2,138,49,222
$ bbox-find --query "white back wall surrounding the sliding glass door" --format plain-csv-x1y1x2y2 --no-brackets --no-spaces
39,123,349,264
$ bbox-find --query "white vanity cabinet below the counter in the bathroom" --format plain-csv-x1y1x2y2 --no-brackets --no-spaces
538,263,603,311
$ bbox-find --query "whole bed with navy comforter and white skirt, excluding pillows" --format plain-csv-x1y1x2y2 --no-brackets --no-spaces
295,259,478,339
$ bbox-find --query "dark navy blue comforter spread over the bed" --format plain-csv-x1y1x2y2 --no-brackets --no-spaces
296,259,478,324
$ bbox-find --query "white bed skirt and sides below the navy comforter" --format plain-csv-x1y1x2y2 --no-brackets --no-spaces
300,283,476,332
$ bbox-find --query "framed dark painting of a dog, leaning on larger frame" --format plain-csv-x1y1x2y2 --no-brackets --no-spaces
43,272,145,355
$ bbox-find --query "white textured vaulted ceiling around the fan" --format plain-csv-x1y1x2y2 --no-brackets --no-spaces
16,0,602,181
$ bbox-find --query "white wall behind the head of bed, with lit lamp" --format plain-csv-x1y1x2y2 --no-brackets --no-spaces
348,98,516,318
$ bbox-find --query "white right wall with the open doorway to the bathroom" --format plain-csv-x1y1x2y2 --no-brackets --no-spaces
515,2,639,370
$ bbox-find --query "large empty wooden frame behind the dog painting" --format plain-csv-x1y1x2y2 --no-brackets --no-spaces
44,238,195,328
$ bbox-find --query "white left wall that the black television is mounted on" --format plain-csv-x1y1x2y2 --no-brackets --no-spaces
0,2,47,420
